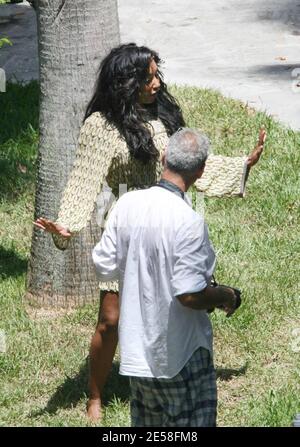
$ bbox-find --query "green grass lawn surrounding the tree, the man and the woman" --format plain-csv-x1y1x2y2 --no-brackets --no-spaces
0,82,300,426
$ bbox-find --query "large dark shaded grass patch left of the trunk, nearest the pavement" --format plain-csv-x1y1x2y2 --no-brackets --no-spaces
0,82,39,201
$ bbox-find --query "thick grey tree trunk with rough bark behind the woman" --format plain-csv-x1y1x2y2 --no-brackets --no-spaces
26,0,119,307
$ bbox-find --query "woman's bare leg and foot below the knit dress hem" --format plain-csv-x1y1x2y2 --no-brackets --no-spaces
87,292,119,421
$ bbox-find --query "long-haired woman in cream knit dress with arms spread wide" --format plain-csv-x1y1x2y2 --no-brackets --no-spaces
35,44,265,420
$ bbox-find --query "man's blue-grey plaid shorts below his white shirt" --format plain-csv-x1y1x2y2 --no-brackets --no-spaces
130,348,217,427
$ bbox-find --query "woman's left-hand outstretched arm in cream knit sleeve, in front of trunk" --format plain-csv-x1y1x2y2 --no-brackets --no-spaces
34,114,116,250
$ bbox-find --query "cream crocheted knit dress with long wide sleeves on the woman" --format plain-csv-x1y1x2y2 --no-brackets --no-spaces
53,112,247,291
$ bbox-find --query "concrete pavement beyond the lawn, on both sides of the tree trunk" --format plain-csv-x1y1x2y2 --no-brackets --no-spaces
0,0,300,130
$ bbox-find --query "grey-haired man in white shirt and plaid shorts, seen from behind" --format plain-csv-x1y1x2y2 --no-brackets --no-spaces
93,128,240,427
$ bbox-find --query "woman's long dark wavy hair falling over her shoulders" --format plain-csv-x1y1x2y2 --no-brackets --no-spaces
84,43,185,163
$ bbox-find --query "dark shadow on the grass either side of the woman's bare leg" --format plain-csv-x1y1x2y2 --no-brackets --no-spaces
30,358,130,418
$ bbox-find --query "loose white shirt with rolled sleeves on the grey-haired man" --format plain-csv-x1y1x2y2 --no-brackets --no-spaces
93,186,215,378
